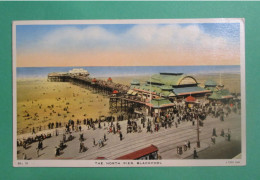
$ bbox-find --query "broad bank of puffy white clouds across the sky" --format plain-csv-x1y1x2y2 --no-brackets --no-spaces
20,25,239,52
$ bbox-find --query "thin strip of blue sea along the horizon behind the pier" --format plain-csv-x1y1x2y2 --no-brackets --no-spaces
16,65,240,78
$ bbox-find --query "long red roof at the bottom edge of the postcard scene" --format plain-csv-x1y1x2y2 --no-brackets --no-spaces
116,145,158,160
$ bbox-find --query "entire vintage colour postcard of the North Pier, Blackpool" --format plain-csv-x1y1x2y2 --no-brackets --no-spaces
13,19,246,167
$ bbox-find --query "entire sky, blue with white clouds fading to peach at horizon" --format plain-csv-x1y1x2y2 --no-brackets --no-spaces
16,23,240,67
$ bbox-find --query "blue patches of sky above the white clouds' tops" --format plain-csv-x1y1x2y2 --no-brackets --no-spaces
16,23,240,47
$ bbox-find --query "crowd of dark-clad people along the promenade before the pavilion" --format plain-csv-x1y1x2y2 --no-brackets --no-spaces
17,97,240,158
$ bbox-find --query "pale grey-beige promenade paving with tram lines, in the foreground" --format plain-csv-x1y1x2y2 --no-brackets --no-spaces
17,113,241,160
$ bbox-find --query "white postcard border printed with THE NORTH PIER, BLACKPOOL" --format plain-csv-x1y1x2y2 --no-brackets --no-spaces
12,18,246,167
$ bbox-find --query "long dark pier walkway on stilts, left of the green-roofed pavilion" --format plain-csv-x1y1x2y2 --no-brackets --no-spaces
48,73,149,113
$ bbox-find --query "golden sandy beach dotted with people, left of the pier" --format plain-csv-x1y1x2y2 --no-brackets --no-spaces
17,78,109,134
